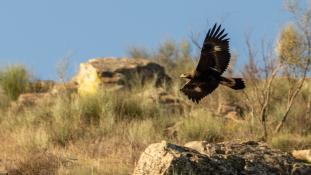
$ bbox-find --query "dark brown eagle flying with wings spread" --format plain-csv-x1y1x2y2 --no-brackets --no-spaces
180,24,245,103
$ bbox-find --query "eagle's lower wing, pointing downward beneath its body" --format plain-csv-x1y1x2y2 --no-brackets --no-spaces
180,80,218,103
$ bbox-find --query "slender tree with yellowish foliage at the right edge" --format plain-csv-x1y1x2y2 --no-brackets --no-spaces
275,0,311,133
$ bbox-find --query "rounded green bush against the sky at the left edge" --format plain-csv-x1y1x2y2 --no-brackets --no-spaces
0,65,31,100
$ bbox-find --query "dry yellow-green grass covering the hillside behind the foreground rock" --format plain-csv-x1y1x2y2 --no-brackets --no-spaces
0,69,310,175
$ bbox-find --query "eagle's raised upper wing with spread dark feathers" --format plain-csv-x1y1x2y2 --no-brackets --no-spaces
196,24,230,74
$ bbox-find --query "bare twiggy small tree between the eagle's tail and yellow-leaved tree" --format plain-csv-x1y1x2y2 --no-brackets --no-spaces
243,36,281,140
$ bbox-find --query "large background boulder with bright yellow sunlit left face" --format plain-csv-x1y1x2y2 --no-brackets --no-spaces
73,58,171,95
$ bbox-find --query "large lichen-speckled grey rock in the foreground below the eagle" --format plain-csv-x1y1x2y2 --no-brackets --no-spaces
133,142,311,175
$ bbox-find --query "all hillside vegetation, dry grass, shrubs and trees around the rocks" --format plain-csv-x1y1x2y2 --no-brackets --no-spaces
0,0,311,175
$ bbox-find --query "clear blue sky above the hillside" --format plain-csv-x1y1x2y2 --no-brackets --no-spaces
0,0,290,79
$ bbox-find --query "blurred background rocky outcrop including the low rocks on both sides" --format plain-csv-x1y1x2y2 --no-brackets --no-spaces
11,58,178,109
